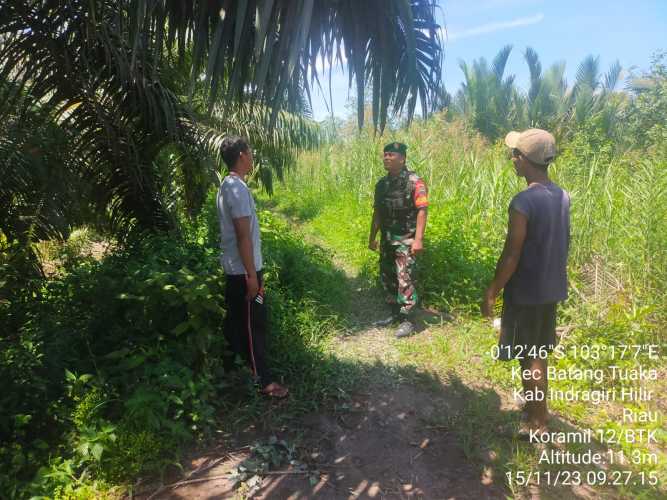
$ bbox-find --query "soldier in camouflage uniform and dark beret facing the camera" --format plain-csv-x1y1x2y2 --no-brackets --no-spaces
368,142,428,338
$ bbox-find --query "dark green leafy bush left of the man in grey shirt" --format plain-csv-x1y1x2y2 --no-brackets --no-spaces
0,231,224,493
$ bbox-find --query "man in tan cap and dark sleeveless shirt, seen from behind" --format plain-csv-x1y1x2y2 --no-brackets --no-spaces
482,129,570,433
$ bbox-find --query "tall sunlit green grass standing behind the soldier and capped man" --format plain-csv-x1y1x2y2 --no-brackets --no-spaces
277,115,667,328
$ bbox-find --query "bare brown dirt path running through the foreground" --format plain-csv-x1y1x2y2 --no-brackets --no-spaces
147,338,506,499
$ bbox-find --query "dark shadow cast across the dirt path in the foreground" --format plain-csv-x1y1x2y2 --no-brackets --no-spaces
144,359,516,499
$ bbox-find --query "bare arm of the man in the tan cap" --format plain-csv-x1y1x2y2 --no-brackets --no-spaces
482,210,528,317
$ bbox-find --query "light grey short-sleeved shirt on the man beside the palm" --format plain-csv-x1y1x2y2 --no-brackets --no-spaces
216,174,262,274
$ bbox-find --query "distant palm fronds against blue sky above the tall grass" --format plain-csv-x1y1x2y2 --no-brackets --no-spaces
448,45,636,144
